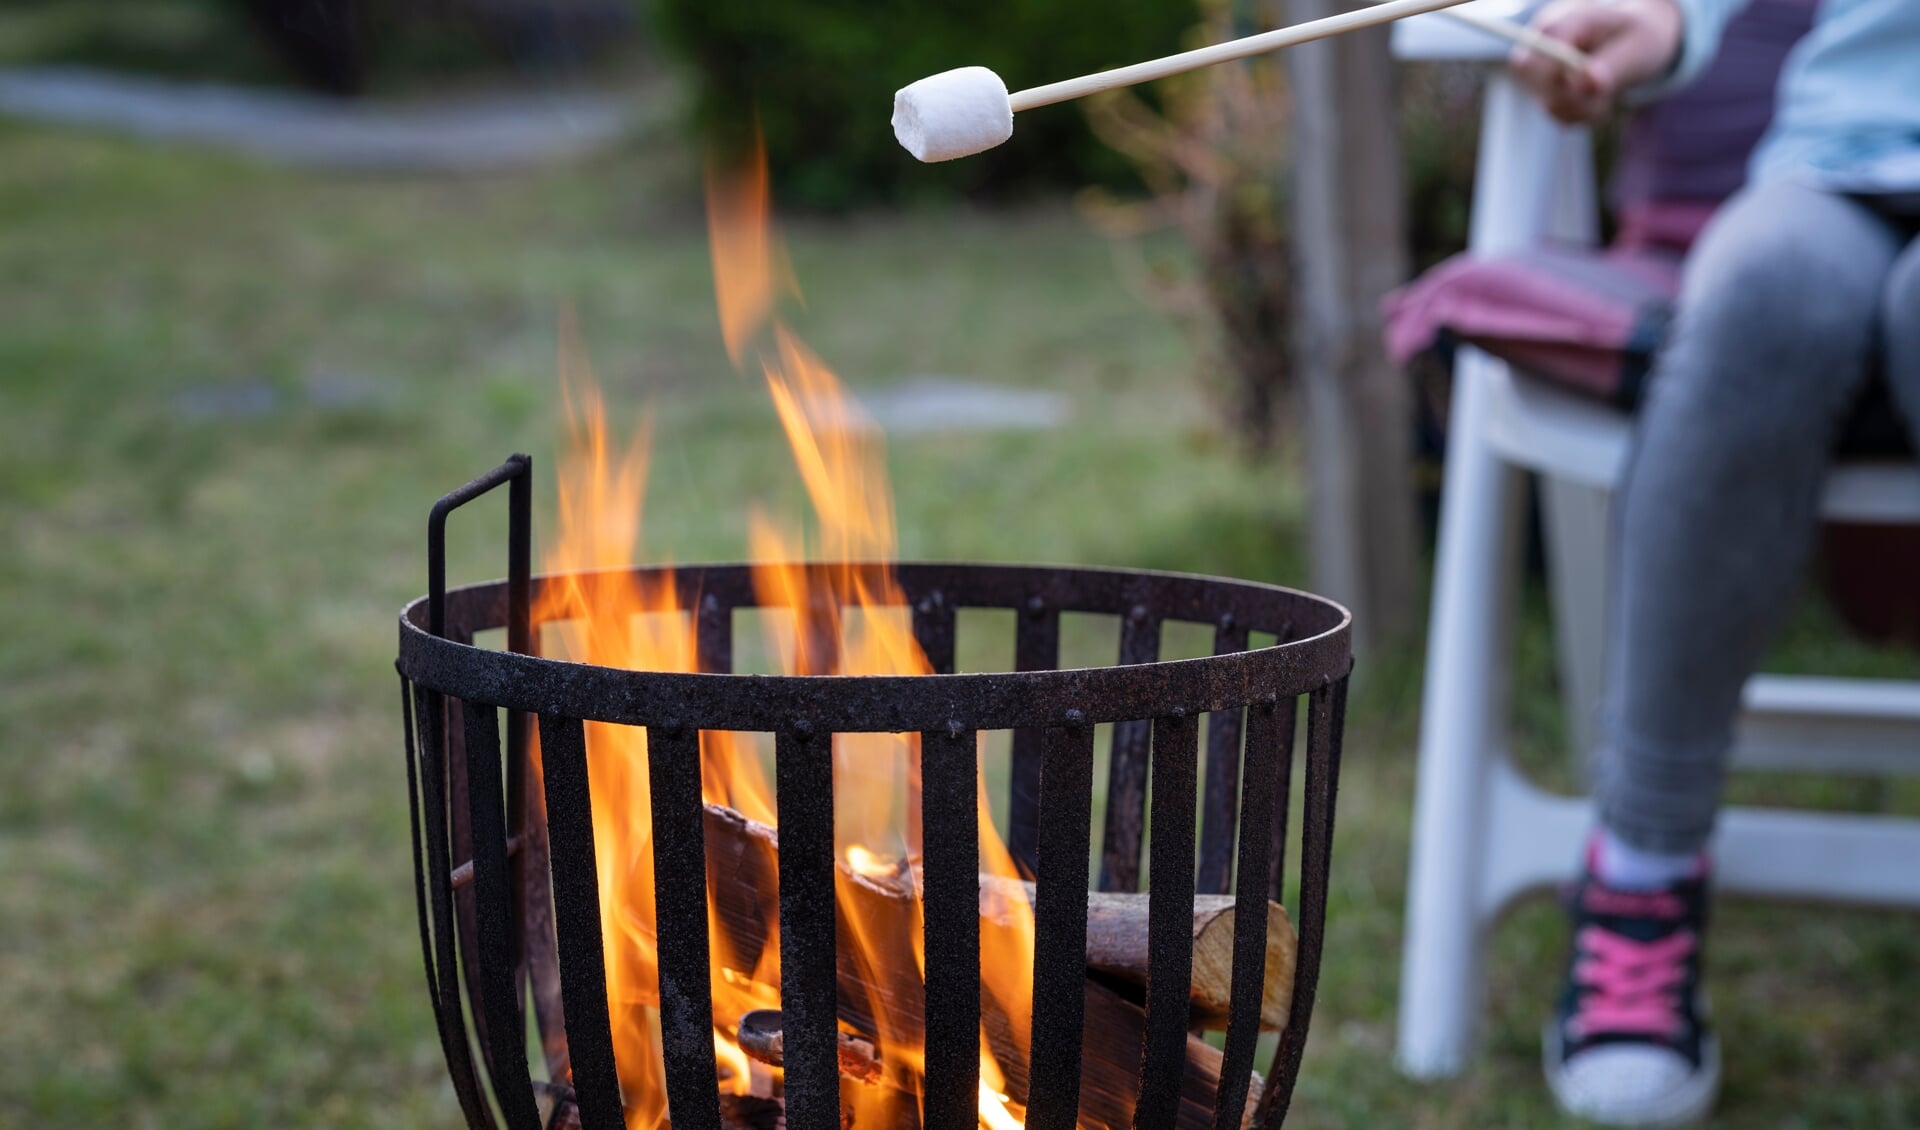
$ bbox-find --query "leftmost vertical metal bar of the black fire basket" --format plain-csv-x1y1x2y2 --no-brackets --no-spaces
413,687,495,1128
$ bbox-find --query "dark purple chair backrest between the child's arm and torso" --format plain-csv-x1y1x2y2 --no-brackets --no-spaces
1609,0,1816,249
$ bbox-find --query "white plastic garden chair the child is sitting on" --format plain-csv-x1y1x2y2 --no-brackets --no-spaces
1394,0,1920,1076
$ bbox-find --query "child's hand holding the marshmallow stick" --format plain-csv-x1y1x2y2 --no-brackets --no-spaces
1511,0,1682,125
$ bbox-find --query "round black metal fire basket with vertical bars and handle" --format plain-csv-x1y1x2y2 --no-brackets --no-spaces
397,455,1352,1130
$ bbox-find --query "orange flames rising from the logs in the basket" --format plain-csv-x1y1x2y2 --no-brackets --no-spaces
536,145,1033,1130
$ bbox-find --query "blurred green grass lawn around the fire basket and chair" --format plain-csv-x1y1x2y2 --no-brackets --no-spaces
11,112,1920,1128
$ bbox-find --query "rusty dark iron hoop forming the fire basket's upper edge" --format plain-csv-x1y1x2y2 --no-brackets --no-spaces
399,564,1348,733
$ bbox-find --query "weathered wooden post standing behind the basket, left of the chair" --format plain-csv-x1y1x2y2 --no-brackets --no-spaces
1275,0,1419,648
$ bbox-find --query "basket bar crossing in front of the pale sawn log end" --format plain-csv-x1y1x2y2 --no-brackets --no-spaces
1213,698,1292,1130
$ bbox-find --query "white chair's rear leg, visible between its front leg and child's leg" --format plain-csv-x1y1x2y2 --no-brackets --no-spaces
1540,476,1611,781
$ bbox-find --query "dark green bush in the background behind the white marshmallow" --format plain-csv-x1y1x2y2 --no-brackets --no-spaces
657,0,1196,207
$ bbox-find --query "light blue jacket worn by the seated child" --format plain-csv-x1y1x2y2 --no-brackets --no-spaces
1663,0,1920,192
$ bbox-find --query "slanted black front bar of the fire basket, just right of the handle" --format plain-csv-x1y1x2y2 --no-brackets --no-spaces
540,714,626,1130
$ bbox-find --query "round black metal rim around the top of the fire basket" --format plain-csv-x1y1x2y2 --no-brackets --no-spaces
397,562,1352,733
